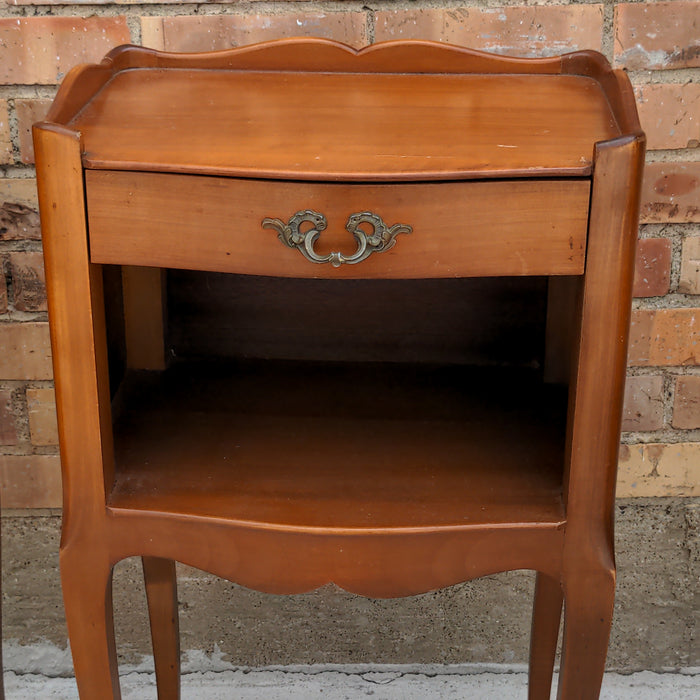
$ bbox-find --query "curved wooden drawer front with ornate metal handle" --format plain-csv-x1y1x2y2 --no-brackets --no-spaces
86,170,589,279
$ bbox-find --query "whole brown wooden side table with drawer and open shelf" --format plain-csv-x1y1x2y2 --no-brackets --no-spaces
34,40,644,700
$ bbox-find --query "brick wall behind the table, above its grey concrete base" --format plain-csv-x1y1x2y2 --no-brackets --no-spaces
0,0,700,508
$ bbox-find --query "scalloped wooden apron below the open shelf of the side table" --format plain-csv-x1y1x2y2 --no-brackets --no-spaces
104,508,564,600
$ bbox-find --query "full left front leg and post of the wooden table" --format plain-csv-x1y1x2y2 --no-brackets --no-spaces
34,125,119,699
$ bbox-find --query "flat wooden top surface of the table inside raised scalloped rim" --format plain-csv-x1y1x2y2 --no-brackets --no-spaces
68,68,620,181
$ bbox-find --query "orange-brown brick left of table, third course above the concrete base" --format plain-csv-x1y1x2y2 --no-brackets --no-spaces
0,323,53,379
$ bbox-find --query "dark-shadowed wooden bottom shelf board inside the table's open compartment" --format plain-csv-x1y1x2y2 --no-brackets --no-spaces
109,360,566,531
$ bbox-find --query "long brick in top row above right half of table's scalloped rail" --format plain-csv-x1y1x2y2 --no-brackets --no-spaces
375,4,603,56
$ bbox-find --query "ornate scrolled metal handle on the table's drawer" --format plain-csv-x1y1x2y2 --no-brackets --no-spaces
262,209,413,267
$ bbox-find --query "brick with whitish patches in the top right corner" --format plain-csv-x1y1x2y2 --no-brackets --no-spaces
615,0,700,70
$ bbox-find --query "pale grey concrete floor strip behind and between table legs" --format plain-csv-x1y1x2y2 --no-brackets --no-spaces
5,665,700,700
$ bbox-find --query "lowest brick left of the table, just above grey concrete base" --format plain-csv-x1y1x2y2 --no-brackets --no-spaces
0,455,63,508
